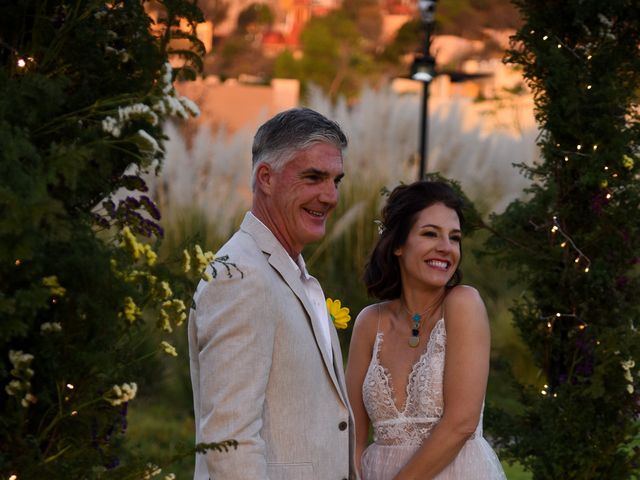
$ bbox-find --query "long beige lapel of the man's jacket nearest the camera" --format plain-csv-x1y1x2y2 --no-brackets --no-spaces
240,213,347,405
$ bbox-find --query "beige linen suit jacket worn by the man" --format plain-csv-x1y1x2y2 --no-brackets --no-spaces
189,213,354,480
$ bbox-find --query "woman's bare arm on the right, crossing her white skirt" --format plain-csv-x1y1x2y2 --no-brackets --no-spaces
395,286,491,480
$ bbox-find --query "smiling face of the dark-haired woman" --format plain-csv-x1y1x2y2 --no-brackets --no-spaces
394,203,462,289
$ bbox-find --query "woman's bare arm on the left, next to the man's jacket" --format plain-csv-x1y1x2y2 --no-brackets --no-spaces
345,305,380,475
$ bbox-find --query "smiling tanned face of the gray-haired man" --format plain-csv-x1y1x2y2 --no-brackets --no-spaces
269,143,344,256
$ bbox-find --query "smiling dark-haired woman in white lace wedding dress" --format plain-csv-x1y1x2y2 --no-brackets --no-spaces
346,181,506,480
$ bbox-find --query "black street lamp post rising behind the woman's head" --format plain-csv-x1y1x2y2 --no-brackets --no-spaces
411,0,437,180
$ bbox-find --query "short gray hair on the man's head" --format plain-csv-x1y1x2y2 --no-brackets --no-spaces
251,108,348,190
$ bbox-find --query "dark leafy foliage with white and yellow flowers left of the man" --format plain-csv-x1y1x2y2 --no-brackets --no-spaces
0,0,234,479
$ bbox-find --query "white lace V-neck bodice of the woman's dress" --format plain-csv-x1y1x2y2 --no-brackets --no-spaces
362,318,447,445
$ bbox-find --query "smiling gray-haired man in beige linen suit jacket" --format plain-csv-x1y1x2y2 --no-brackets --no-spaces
189,108,354,480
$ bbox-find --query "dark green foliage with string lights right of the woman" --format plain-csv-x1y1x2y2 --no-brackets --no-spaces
487,0,640,480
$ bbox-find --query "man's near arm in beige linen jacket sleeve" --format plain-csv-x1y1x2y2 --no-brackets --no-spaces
190,260,276,480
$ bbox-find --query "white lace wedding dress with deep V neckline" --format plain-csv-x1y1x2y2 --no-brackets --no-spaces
362,319,506,480
